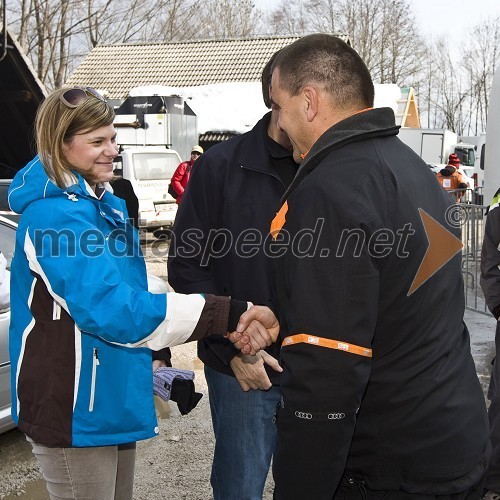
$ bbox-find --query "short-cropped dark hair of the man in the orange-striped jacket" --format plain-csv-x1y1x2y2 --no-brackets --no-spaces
271,34,375,109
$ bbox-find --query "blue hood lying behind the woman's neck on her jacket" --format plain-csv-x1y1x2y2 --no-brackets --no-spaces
8,155,89,214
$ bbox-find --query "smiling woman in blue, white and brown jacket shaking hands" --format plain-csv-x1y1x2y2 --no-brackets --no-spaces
9,87,279,500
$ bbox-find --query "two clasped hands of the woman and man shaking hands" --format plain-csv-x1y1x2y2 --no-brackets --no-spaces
226,306,280,356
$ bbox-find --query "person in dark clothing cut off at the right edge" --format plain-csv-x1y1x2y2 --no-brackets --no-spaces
480,189,500,500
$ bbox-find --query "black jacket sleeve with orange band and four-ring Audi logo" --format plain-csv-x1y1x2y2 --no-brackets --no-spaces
273,188,379,500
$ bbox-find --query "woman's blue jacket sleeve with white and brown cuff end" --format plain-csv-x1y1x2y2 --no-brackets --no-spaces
23,205,246,350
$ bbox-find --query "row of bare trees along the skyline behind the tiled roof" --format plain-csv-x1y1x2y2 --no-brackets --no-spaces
4,0,500,134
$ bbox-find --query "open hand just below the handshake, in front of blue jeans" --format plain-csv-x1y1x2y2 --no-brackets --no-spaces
231,351,283,392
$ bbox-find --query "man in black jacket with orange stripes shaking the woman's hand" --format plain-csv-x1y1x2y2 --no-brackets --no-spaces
270,35,490,500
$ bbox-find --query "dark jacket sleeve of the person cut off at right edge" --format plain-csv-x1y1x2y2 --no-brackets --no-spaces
480,201,500,320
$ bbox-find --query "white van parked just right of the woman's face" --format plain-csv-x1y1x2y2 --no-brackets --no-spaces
114,146,181,230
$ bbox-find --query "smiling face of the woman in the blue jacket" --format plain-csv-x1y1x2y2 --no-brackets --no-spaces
63,125,118,188
